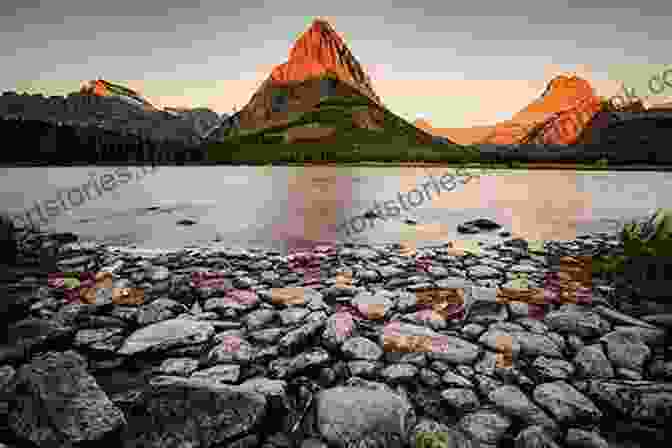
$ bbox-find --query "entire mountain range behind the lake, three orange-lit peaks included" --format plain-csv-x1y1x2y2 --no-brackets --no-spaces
0,19,672,157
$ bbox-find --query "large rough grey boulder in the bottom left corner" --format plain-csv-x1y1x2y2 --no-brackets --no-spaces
9,351,126,447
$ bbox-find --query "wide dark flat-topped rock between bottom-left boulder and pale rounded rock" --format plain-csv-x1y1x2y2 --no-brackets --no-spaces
126,376,267,448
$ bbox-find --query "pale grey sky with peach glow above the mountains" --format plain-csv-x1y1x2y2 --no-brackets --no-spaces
0,0,672,128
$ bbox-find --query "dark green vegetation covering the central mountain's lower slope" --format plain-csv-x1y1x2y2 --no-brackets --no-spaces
208,96,479,164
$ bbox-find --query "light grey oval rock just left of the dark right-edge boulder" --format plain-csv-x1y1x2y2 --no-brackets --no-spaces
533,381,602,423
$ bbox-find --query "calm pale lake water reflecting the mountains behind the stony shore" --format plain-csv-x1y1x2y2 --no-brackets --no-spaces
0,166,672,251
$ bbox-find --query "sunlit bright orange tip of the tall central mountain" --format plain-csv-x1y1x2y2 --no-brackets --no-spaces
270,18,380,104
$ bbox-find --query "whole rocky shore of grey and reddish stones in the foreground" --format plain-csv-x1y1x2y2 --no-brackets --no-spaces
0,234,672,448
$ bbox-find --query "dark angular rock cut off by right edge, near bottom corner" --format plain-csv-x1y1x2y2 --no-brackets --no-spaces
587,380,672,427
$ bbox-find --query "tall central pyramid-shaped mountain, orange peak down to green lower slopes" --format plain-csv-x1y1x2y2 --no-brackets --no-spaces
209,19,452,144
